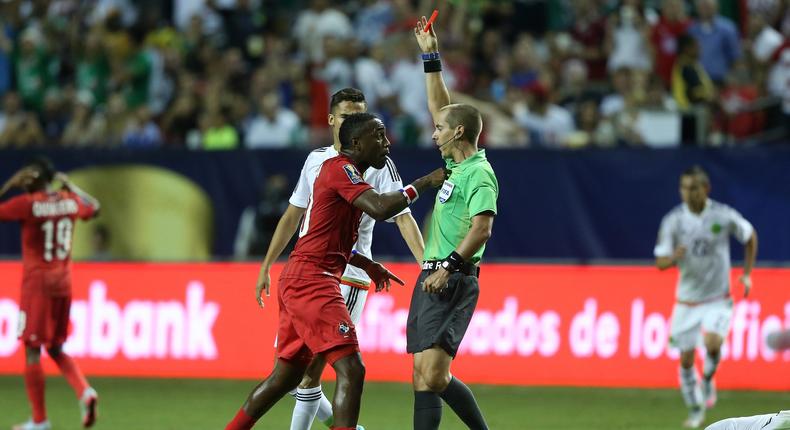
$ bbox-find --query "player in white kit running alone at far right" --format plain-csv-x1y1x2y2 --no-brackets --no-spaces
653,166,757,428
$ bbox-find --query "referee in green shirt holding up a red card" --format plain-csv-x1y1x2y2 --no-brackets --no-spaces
406,16,499,430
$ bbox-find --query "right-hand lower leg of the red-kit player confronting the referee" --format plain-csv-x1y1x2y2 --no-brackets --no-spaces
324,345,365,430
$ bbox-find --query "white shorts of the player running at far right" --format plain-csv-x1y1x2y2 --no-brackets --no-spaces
669,299,732,351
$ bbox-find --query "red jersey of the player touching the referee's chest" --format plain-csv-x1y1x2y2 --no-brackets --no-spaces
290,154,373,279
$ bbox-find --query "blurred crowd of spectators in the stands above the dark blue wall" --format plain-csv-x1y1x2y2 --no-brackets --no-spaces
0,0,790,150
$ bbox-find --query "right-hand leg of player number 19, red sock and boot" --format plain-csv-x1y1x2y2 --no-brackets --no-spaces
47,297,99,427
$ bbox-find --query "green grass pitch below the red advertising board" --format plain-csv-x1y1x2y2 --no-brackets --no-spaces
0,376,790,430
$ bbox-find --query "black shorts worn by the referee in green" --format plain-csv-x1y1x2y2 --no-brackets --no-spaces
406,270,480,357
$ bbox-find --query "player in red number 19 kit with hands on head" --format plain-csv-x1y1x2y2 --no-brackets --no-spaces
0,159,99,430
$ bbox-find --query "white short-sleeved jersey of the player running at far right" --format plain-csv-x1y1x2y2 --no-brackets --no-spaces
653,199,754,302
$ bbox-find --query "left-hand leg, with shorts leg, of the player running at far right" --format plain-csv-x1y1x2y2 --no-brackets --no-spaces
670,304,705,428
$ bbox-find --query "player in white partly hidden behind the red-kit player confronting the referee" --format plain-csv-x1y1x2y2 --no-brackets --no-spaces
255,88,425,430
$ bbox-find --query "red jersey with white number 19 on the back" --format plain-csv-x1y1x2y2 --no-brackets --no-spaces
0,190,96,284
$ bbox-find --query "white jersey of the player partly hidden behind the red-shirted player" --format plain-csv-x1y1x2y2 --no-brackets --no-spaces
288,146,411,284
